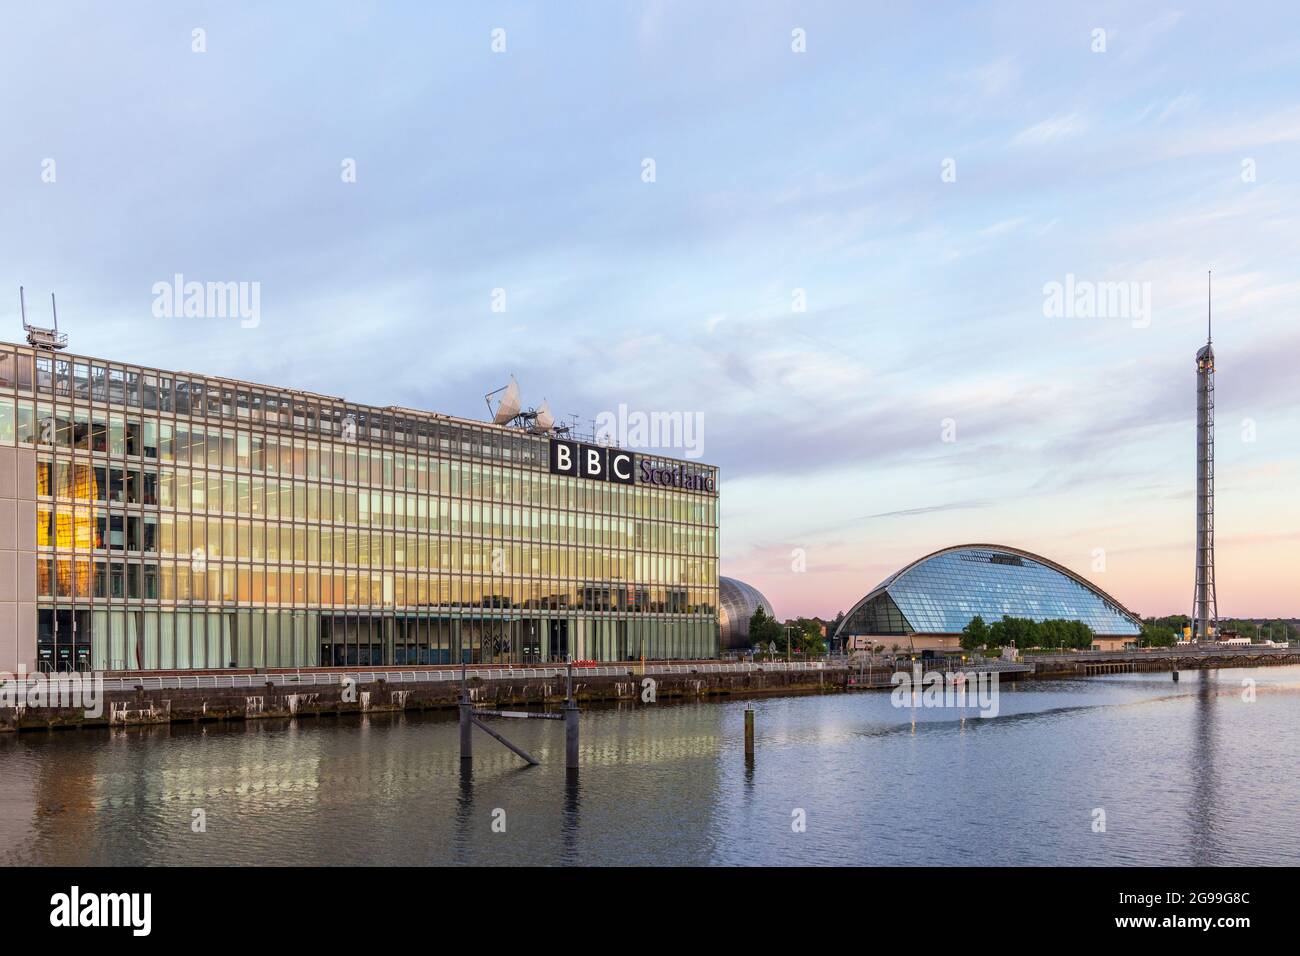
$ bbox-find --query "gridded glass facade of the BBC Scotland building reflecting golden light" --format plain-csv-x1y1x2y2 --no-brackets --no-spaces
0,345,718,670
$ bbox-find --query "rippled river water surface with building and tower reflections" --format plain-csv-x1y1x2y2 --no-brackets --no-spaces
0,667,1300,865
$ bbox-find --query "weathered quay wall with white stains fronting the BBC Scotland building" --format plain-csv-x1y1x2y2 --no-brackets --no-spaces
0,662,852,731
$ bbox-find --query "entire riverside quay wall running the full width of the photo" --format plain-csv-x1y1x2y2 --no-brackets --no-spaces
0,645,1300,732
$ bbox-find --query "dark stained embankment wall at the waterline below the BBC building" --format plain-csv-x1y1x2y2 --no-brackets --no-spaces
0,666,849,731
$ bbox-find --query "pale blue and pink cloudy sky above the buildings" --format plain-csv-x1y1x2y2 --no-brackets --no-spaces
0,0,1300,618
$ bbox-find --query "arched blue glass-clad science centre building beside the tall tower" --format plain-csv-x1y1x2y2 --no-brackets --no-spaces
836,545,1141,649
